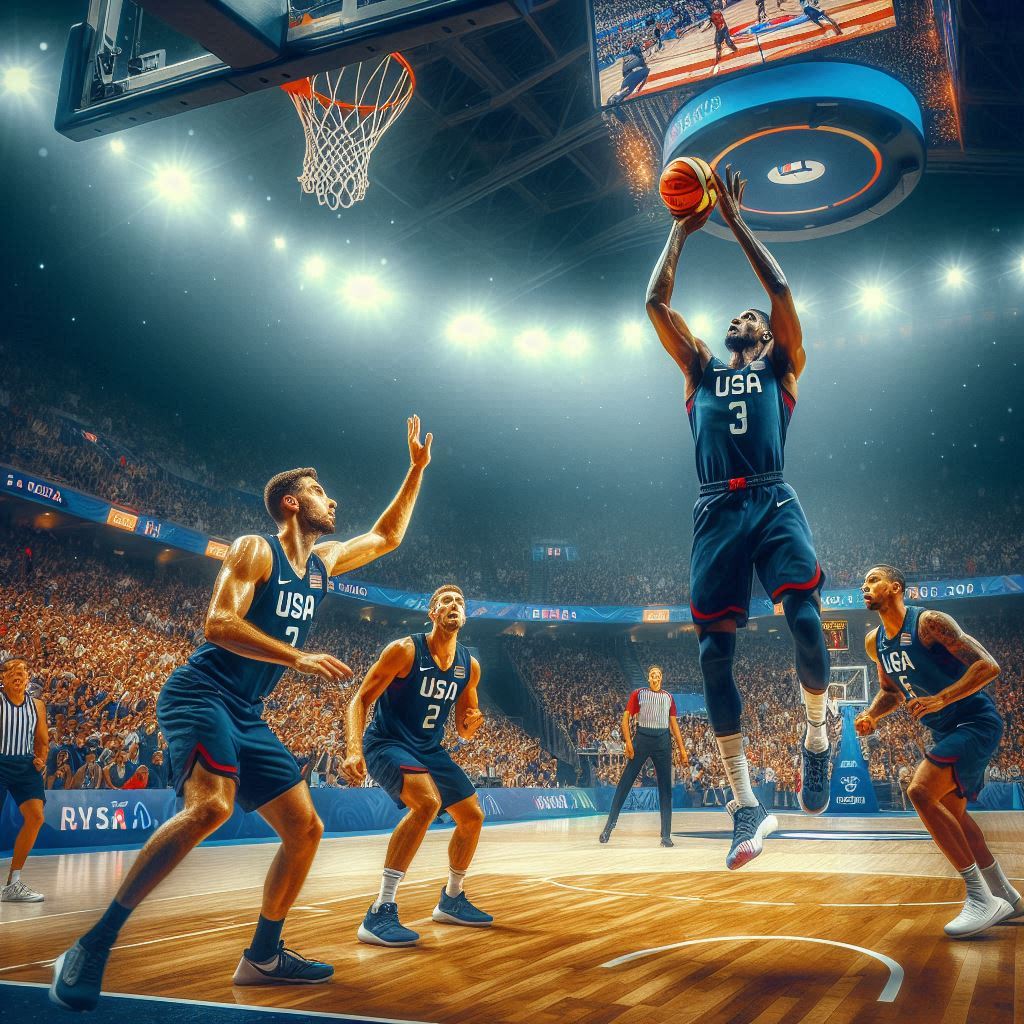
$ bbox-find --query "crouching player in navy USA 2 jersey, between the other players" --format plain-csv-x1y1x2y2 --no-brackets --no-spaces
342,584,494,946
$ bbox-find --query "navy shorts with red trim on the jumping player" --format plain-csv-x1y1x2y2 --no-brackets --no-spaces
690,483,825,626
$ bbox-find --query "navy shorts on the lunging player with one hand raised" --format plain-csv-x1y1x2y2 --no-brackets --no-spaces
157,665,302,811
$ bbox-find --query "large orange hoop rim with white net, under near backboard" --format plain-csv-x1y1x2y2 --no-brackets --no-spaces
282,53,416,210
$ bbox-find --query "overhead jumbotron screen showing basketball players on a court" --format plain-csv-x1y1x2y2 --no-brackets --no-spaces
591,0,896,108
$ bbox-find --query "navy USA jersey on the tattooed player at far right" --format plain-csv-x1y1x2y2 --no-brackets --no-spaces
874,604,998,732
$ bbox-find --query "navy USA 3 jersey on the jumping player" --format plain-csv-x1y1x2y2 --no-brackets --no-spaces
686,354,797,483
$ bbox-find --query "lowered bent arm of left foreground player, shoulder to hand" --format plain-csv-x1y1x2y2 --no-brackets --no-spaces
204,535,352,680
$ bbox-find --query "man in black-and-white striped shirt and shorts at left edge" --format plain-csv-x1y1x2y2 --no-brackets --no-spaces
0,657,49,903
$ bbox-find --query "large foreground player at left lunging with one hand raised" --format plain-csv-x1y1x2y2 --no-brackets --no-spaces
50,416,432,1010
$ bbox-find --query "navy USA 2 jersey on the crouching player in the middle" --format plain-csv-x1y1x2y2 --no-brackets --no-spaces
367,633,471,754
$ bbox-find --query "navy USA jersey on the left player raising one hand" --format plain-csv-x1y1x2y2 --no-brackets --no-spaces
188,534,328,705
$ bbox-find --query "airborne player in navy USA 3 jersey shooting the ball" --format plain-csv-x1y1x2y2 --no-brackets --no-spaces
647,168,829,868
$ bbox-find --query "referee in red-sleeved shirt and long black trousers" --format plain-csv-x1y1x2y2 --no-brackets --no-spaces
601,665,690,846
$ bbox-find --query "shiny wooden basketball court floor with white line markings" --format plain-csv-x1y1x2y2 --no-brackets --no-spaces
0,811,1024,1024
